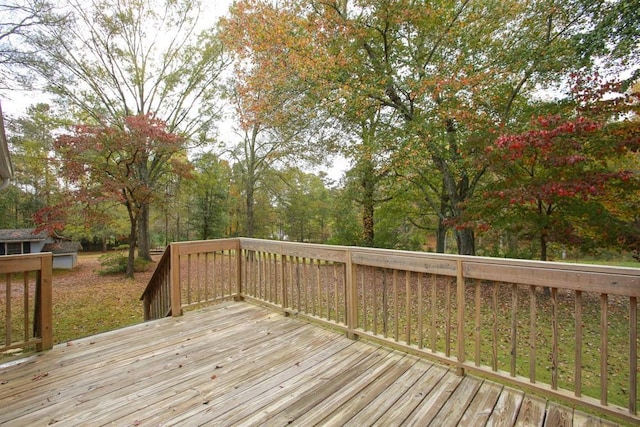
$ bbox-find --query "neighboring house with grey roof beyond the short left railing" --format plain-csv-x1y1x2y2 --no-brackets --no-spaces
0,228,82,269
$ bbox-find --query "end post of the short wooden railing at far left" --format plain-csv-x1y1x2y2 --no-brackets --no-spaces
34,253,53,351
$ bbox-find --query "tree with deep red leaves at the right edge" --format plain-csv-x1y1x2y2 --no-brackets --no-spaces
480,78,640,260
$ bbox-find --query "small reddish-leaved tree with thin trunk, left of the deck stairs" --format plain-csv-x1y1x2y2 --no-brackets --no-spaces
56,115,189,276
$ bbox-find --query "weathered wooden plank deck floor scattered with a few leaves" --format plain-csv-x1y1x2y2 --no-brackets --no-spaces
0,302,614,426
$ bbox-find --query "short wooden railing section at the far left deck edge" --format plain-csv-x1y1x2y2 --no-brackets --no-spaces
0,253,53,353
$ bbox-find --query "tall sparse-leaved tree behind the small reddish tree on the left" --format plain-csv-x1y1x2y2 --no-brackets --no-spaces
29,0,226,258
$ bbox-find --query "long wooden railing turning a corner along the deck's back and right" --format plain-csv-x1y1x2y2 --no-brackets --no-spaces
143,238,640,423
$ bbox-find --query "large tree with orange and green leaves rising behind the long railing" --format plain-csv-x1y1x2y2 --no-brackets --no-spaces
222,0,608,254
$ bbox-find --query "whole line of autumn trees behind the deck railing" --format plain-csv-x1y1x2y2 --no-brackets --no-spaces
0,0,640,274
